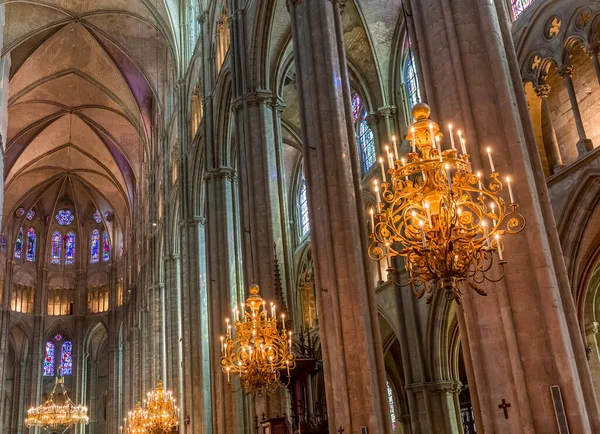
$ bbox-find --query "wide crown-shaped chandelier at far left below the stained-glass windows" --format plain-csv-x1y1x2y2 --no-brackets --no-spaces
25,377,89,433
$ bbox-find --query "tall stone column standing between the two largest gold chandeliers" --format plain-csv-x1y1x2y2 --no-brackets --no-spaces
287,0,392,434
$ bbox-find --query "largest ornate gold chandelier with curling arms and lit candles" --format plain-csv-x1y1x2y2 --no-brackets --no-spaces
369,104,525,303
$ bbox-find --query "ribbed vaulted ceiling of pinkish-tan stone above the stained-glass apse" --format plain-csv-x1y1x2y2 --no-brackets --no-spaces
0,0,179,234
